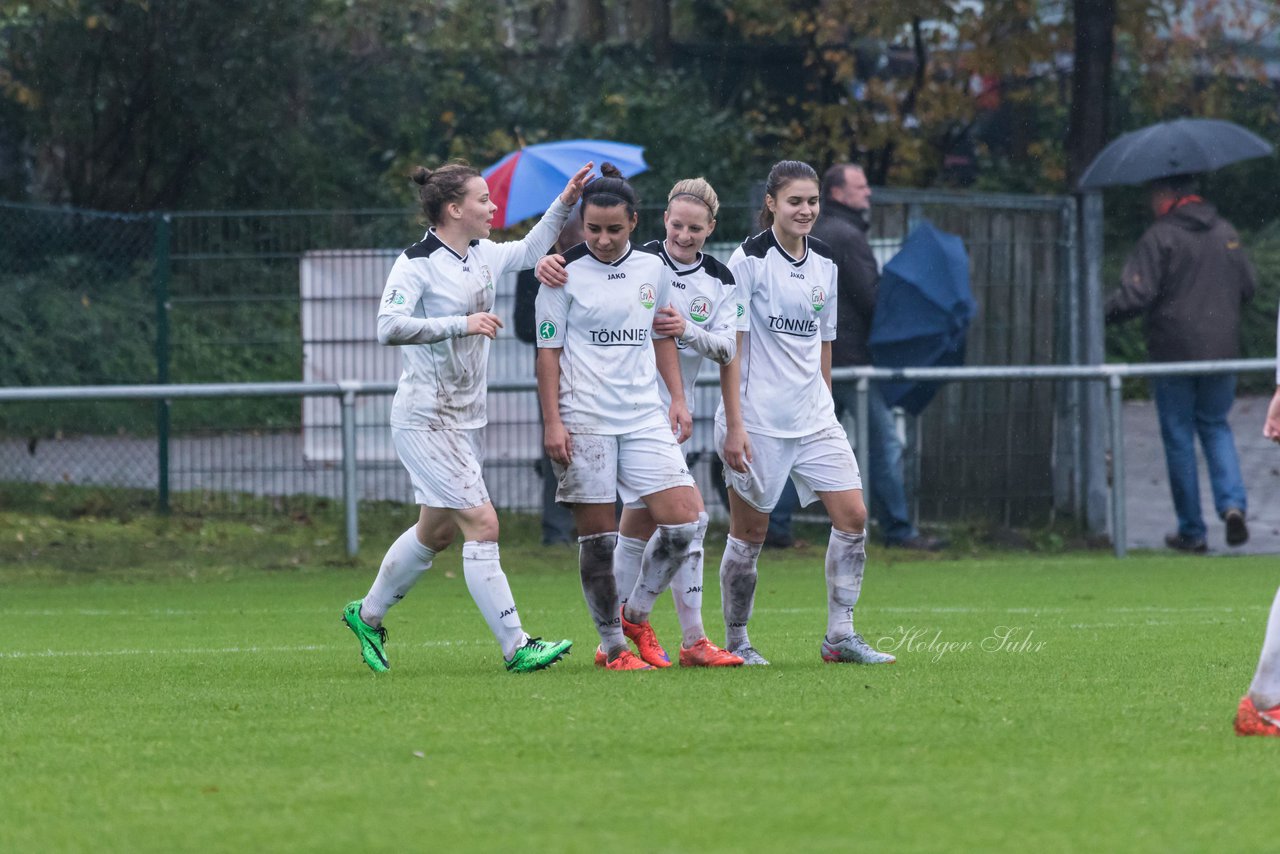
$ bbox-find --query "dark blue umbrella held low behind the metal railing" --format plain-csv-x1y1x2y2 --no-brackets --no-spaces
868,222,978,415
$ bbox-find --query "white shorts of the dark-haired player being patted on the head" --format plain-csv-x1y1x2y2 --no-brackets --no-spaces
552,426,694,504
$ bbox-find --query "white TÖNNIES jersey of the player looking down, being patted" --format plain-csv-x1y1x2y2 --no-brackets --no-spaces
536,243,671,435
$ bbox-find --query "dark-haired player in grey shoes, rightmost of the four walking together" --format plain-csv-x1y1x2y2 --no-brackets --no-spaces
716,160,895,665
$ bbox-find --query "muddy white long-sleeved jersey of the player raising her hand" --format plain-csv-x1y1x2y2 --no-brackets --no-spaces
378,197,572,430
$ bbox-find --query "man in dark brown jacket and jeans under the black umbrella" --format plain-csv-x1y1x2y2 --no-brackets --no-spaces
1106,175,1257,552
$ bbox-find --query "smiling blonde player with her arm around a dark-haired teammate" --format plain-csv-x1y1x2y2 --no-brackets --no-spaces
538,178,742,667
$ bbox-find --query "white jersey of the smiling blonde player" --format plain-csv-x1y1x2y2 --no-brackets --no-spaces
645,241,737,414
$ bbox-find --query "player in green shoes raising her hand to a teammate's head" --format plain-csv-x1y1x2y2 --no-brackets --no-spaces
342,156,591,672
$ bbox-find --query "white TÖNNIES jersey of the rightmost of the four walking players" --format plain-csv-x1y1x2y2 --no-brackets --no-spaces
716,229,840,438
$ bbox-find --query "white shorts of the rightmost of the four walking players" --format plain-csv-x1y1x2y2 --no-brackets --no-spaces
716,421,863,513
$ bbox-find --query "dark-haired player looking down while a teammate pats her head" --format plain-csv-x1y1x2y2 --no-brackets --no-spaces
536,164,700,671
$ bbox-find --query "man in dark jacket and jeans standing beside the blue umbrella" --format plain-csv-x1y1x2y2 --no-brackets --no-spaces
764,163,946,552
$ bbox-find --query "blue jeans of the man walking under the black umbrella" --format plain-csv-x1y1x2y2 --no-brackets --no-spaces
1151,374,1248,539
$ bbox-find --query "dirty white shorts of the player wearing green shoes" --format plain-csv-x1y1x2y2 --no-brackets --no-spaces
392,428,489,510
